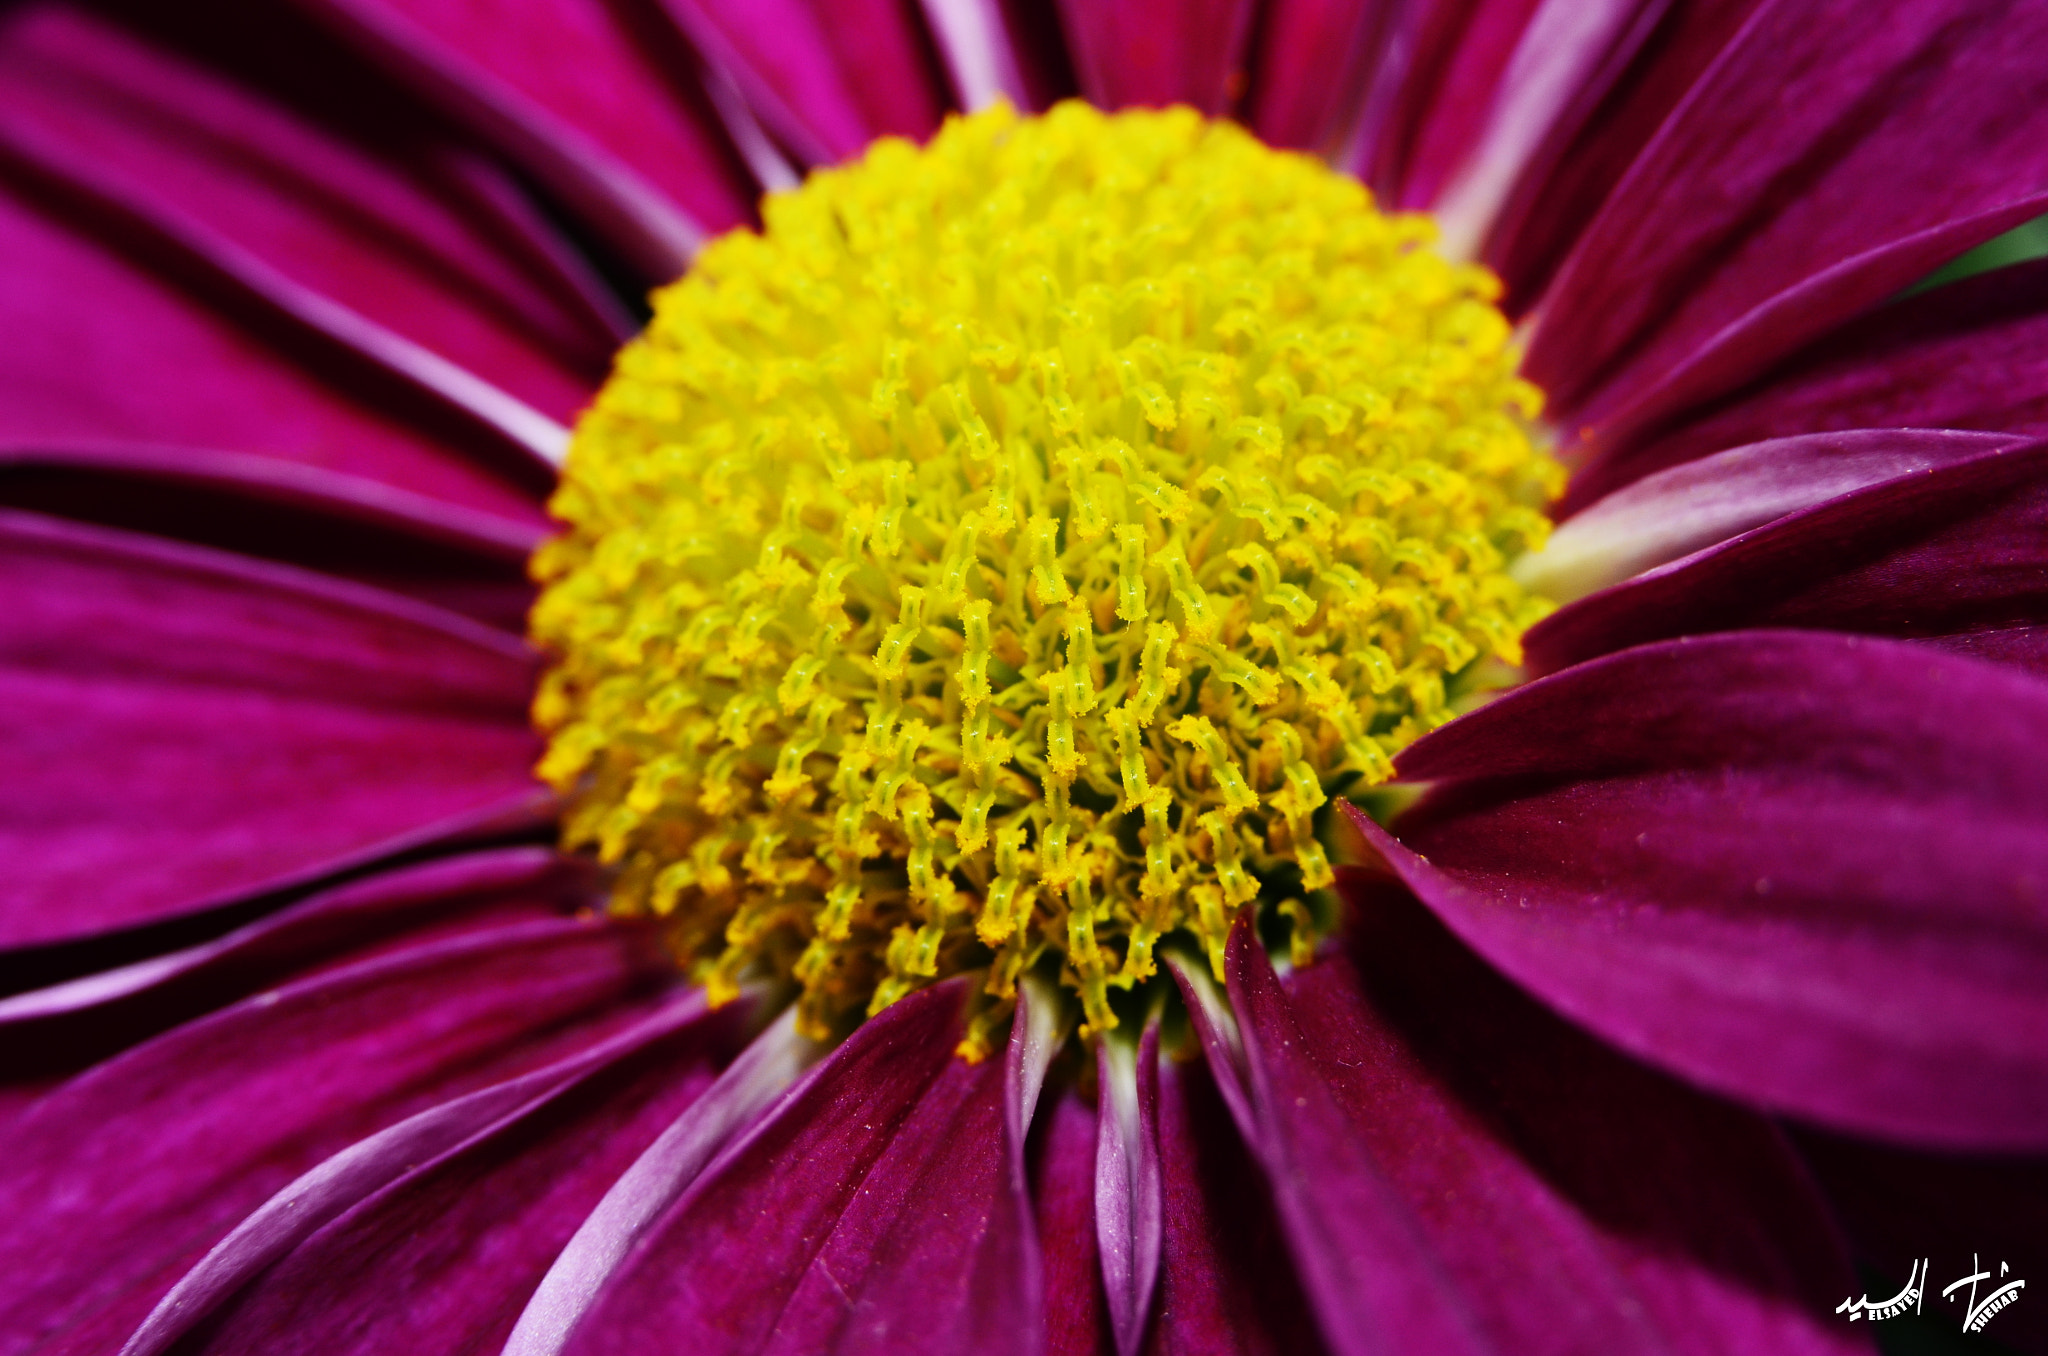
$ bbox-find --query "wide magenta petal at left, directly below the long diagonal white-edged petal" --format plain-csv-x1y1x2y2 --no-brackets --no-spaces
0,161,539,520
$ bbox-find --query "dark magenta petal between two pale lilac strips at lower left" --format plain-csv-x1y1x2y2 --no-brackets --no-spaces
142,993,743,1356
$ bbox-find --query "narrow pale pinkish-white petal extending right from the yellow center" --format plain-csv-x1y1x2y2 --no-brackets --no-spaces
1516,428,2021,602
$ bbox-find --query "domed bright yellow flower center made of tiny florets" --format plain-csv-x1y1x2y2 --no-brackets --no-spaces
532,104,1559,1053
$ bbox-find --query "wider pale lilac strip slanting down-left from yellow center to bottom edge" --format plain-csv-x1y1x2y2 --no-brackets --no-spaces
504,1010,817,1356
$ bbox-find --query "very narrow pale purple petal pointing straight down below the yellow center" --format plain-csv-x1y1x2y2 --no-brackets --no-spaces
1096,1022,1161,1356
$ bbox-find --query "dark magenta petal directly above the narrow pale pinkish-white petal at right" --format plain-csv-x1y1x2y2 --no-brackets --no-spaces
1563,260,2048,510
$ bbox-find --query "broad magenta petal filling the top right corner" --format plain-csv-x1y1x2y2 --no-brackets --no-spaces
1526,0,2048,440
